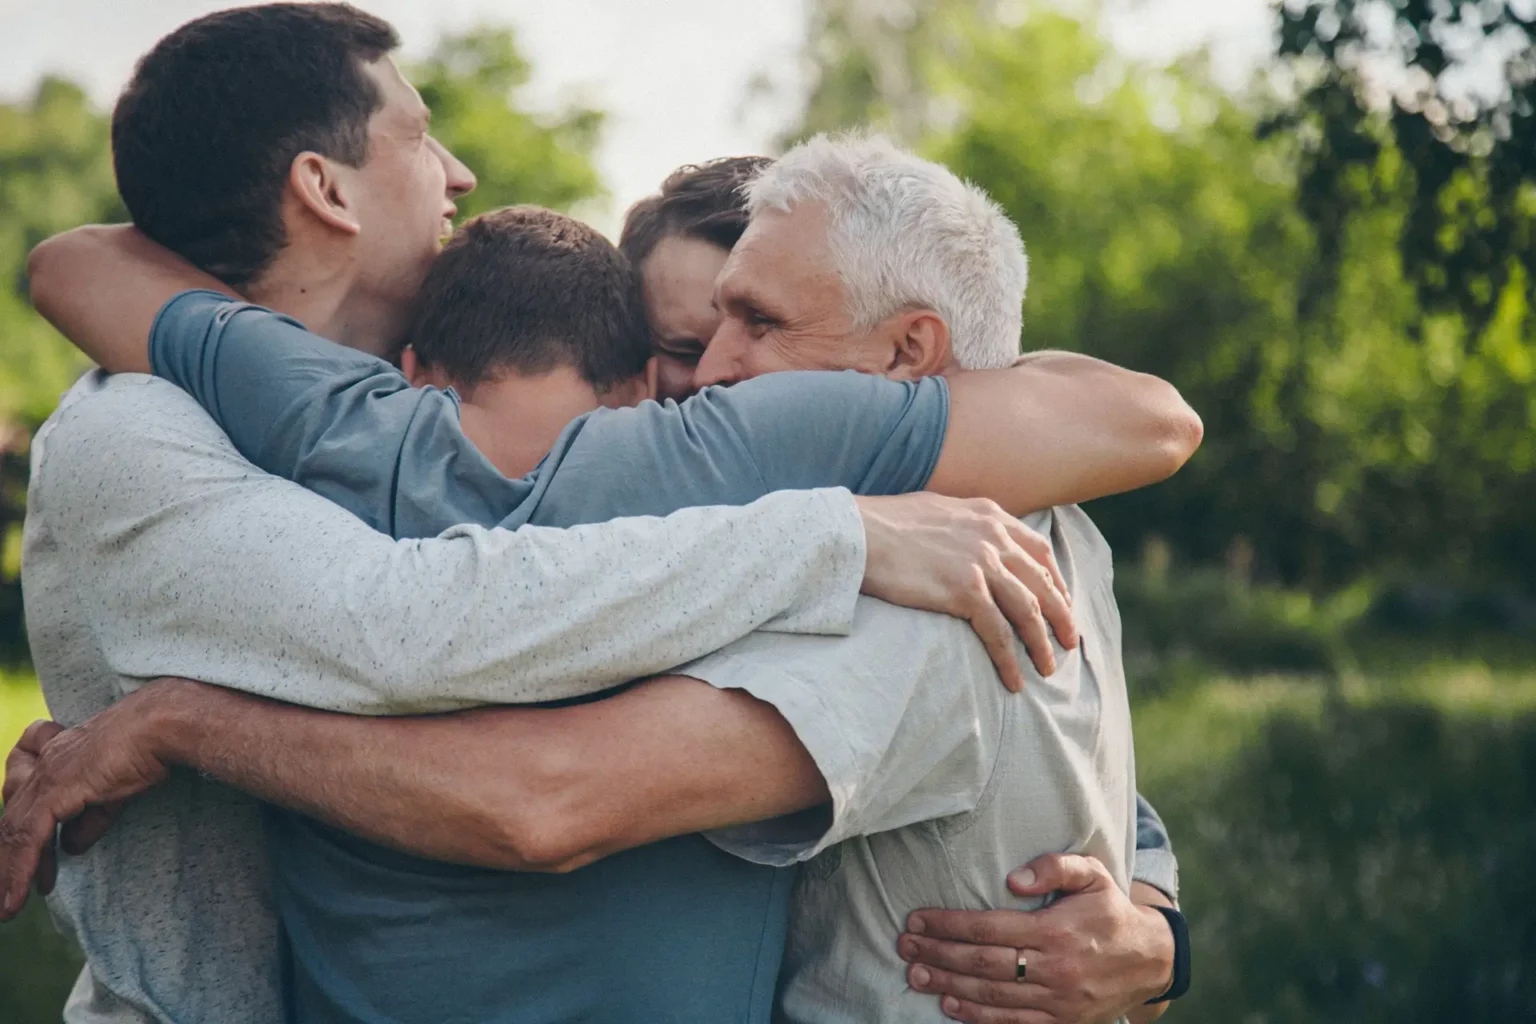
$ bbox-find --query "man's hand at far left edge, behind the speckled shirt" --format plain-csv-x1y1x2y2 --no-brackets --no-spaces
0,689,175,921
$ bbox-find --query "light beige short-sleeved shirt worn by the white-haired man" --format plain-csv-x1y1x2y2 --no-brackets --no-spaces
677,508,1137,1024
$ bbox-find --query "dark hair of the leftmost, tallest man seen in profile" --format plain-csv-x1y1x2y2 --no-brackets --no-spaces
112,3,399,287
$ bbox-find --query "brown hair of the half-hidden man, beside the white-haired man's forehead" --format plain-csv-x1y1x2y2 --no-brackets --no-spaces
619,157,773,267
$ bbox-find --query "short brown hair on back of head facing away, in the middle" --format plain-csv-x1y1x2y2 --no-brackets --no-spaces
407,206,651,393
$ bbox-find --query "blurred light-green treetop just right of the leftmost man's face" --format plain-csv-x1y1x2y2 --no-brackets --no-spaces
407,29,602,215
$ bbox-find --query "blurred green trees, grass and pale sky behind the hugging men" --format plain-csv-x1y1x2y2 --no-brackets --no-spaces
0,0,1536,1024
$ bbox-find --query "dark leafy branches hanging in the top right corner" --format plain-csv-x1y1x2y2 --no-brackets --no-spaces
1276,0,1536,330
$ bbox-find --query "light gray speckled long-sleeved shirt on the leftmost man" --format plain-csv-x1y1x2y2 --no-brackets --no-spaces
23,375,865,1024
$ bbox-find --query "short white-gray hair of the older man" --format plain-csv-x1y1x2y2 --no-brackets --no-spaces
743,135,1029,370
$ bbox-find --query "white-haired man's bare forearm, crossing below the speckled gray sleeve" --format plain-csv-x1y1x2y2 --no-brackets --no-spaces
144,677,826,870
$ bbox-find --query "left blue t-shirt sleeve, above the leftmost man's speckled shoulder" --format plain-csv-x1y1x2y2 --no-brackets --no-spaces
149,292,525,537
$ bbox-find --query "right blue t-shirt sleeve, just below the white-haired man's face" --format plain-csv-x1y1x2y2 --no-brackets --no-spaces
531,372,949,525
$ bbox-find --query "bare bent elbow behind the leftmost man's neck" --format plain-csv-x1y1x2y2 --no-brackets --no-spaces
28,224,233,373
